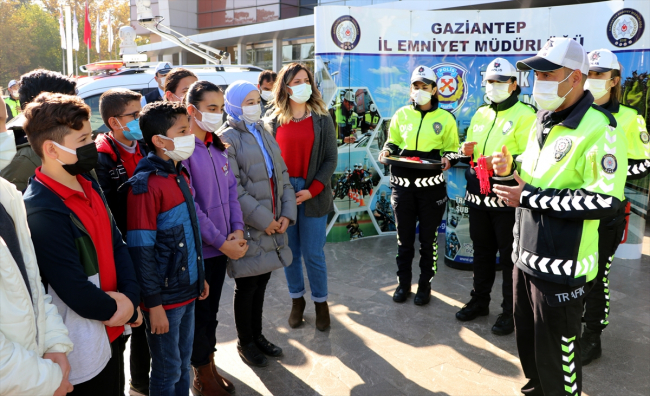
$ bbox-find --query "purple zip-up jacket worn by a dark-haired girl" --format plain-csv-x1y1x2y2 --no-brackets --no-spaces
183,137,244,258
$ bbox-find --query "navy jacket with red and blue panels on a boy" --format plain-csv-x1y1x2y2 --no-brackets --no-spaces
122,153,205,308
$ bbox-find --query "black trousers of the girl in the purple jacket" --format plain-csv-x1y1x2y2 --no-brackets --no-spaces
190,256,228,367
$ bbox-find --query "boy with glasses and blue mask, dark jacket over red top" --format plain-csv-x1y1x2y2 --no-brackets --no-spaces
95,88,151,395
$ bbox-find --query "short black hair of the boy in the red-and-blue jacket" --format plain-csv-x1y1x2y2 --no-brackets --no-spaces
140,101,187,152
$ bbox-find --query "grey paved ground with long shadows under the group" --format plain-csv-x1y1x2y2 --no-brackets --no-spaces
127,232,650,396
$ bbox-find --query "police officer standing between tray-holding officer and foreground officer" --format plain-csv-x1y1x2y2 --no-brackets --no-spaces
456,58,537,335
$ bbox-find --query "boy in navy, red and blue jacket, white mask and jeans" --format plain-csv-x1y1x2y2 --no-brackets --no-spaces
127,102,209,396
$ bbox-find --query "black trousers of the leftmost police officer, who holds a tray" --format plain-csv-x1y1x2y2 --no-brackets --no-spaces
391,187,447,287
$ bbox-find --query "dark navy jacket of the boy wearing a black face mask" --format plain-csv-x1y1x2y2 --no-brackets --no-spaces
24,175,140,322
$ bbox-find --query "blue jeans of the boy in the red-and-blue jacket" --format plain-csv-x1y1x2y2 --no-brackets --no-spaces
142,301,194,396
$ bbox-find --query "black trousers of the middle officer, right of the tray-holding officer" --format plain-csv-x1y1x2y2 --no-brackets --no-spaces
469,207,515,315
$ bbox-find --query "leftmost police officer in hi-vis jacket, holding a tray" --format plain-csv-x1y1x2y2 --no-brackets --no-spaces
379,66,458,305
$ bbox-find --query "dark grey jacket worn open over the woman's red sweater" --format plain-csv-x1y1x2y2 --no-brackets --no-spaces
263,113,338,217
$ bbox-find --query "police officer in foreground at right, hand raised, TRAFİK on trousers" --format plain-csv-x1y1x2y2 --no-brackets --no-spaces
492,37,627,396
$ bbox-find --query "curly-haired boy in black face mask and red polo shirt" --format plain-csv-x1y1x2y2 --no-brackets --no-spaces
24,92,141,396
